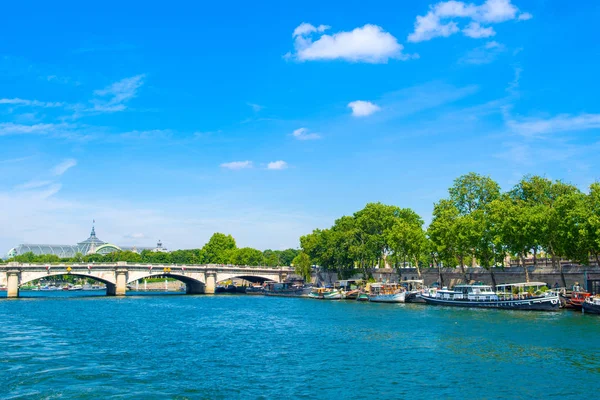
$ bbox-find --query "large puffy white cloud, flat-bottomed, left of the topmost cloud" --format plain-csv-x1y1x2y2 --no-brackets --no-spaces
286,23,417,63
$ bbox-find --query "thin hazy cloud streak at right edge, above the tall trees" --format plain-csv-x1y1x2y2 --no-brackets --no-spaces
507,114,600,137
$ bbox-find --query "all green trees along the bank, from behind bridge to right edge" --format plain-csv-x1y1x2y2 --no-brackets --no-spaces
8,172,600,286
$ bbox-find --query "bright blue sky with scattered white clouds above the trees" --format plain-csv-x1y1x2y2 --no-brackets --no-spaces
0,0,600,250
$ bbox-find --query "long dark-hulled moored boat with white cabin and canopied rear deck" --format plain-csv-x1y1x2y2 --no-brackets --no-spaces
421,282,561,311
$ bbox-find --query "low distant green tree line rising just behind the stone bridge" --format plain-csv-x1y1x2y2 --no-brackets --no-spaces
8,233,300,267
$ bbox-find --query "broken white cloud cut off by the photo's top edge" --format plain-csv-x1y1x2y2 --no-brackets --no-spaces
408,0,533,42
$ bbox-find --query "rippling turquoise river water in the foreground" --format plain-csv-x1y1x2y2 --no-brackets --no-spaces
0,292,600,399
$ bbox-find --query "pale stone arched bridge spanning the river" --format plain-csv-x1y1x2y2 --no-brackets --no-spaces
0,262,294,297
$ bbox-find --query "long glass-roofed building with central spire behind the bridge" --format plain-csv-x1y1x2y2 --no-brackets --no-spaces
7,226,167,258
